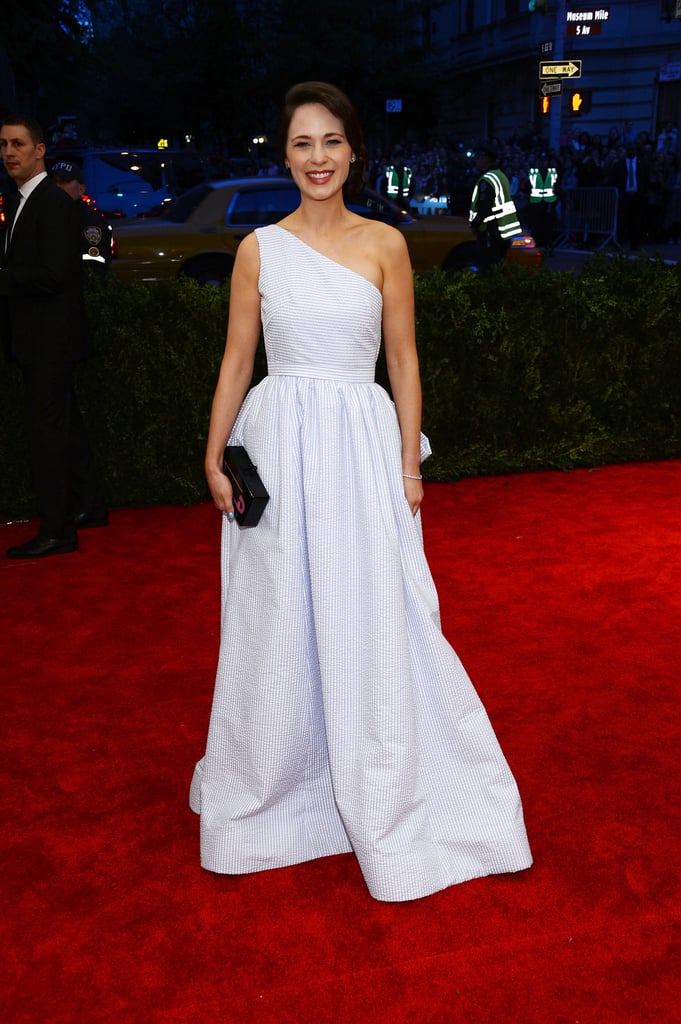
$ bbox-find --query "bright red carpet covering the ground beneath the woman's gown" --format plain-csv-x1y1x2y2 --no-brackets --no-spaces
0,462,681,1024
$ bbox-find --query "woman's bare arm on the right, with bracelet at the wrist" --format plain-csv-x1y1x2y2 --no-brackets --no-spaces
381,228,423,515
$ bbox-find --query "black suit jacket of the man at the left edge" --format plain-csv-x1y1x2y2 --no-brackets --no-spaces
0,177,89,364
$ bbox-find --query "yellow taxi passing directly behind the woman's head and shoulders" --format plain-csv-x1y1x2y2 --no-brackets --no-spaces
113,178,542,285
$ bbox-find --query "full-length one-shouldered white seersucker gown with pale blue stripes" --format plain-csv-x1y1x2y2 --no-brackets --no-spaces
190,225,531,901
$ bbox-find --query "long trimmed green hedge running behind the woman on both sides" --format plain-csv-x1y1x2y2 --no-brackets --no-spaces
0,257,681,517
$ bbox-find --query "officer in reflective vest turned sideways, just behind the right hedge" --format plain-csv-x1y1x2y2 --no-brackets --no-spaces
469,144,521,271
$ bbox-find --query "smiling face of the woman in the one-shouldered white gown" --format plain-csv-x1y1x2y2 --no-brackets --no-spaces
286,103,353,199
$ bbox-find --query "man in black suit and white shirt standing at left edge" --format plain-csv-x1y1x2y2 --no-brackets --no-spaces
0,115,107,558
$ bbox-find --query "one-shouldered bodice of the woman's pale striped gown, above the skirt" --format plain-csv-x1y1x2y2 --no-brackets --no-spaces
256,224,383,381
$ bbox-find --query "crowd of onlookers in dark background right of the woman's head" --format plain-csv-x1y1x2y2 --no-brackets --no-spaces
358,122,681,248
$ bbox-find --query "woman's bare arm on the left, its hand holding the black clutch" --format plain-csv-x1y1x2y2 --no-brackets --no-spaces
206,234,260,512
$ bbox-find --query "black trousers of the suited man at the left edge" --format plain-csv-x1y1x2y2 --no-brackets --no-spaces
22,362,105,538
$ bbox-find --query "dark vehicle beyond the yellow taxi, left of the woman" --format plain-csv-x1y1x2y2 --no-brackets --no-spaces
47,147,254,218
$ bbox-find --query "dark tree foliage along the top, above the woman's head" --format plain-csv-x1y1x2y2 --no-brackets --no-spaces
3,0,446,152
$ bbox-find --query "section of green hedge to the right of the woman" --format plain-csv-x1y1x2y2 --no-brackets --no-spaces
417,257,681,479
